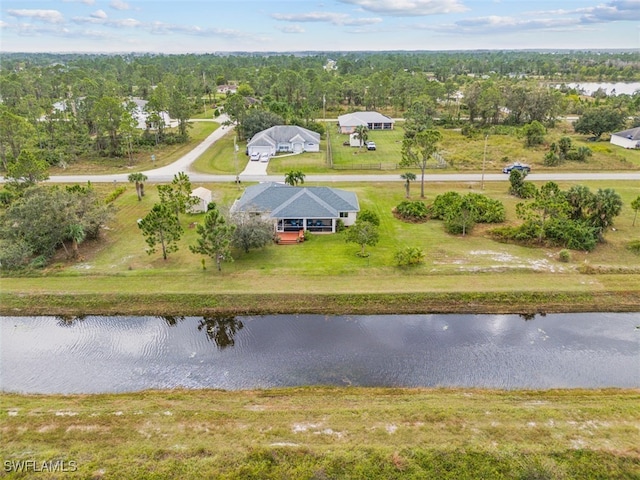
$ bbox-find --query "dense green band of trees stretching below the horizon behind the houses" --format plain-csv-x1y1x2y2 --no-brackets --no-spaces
0,48,640,175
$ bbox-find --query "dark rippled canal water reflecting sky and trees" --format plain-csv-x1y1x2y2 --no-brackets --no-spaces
0,313,640,393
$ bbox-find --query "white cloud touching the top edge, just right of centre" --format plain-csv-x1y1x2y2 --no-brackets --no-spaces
338,0,469,17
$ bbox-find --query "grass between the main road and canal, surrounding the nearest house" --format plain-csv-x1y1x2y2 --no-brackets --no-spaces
0,181,640,313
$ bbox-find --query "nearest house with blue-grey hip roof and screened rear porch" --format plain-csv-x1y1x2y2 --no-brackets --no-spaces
231,182,360,233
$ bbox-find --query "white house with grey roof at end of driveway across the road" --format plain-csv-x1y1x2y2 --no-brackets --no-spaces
247,125,320,155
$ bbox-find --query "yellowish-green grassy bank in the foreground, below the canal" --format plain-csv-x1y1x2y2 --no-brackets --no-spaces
0,387,640,480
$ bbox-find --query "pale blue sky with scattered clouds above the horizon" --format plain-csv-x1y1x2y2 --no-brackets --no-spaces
0,0,640,53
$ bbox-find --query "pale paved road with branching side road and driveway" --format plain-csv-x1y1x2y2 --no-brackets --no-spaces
27,116,640,183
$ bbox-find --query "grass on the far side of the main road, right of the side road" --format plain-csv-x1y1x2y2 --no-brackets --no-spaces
190,122,640,175
